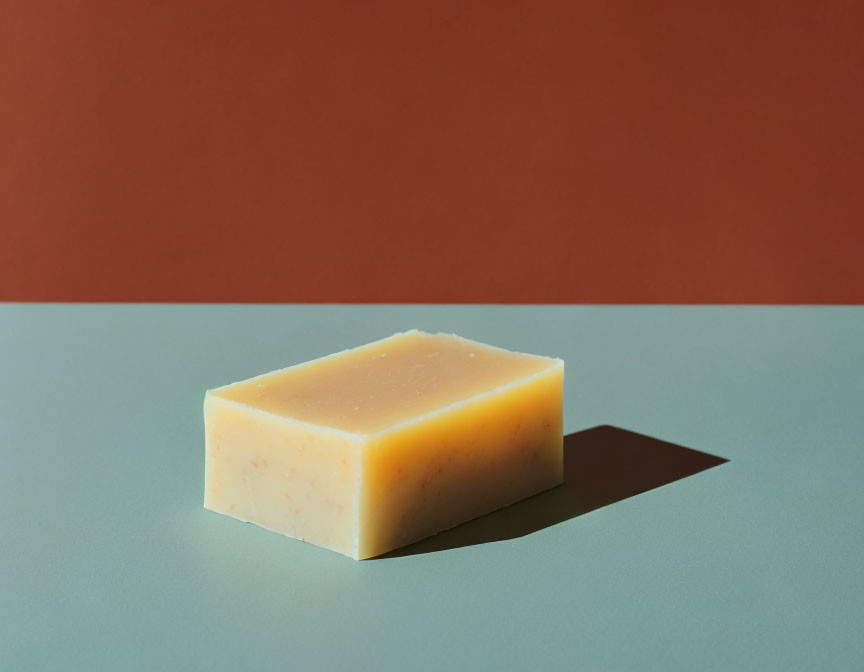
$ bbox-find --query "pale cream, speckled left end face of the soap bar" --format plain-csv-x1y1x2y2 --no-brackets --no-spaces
204,393,364,558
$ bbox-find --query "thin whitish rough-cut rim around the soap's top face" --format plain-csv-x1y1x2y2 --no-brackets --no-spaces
204,329,564,439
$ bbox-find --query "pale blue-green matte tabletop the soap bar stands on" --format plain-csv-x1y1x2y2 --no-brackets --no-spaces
0,305,864,672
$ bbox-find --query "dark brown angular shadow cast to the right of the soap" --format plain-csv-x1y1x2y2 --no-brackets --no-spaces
378,425,728,558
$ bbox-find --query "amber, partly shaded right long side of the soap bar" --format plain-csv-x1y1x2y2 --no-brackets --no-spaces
358,365,564,558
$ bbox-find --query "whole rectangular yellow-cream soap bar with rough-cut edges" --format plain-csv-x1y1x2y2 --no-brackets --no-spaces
204,331,564,559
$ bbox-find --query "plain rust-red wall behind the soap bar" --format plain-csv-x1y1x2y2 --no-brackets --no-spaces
0,0,864,303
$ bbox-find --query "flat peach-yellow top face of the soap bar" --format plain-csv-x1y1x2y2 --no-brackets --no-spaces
210,331,563,434
